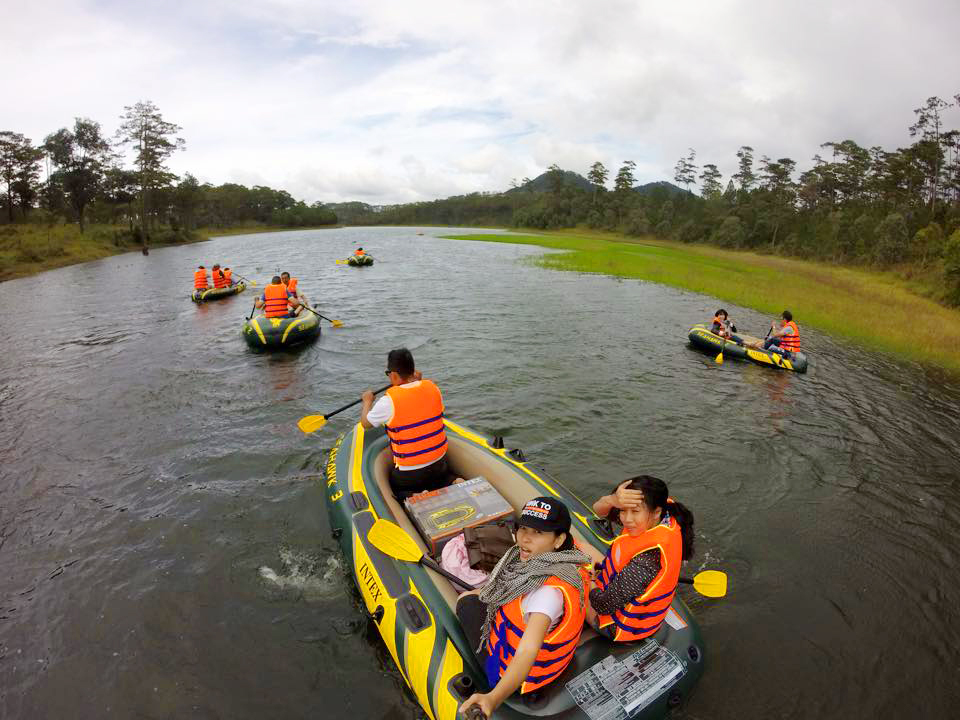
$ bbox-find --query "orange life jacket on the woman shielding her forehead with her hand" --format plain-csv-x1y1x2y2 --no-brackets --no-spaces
597,515,683,642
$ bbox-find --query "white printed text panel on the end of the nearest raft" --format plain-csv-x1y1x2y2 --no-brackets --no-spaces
567,640,687,720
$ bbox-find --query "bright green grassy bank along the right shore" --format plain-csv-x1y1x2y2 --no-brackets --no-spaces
449,231,960,372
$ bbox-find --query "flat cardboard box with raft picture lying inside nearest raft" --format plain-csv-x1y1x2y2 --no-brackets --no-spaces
403,477,513,556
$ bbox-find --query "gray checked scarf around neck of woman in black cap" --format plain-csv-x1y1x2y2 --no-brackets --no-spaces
477,545,590,652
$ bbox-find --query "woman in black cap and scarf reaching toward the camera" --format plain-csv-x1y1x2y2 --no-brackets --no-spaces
457,497,590,717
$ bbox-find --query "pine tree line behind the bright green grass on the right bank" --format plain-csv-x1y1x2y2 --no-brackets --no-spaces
354,94,960,305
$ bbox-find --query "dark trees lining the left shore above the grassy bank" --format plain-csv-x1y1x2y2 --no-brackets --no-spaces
0,101,337,240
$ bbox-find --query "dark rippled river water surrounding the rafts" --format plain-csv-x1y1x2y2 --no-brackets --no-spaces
0,228,960,720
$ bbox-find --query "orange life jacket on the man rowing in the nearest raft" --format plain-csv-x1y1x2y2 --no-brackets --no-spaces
387,380,447,467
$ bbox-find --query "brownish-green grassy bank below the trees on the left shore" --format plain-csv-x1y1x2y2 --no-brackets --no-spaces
0,223,338,281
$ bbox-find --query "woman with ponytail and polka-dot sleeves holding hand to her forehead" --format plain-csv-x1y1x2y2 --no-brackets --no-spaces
587,475,693,642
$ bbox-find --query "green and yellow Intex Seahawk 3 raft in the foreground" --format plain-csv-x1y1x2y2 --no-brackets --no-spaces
326,420,704,720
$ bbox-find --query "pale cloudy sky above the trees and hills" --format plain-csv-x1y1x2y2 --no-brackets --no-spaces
7,0,960,203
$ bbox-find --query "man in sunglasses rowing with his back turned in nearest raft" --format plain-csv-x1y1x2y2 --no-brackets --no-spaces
360,348,451,502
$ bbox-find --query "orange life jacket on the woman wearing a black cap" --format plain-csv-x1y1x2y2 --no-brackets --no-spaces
486,568,590,694
